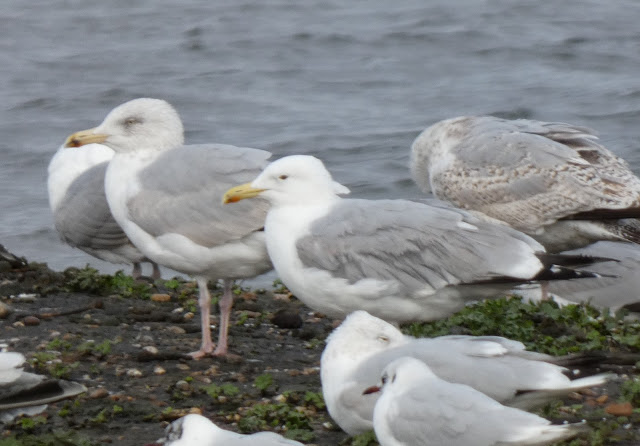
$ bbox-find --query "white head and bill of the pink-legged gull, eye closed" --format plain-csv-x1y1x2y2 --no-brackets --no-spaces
65,98,184,153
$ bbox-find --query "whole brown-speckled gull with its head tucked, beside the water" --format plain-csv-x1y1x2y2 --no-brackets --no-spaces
410,116,640,252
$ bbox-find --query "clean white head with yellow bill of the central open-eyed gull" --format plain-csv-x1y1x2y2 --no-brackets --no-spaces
224,155,349,206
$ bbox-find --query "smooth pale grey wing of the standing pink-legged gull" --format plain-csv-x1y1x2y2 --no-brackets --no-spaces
127,144,271,247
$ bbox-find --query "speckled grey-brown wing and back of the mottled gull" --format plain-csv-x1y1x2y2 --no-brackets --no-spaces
419,116,640,231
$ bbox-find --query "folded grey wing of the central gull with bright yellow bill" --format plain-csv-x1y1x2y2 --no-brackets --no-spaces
296,200,542,292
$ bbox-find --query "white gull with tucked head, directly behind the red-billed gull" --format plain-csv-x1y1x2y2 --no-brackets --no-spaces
320,311,614,435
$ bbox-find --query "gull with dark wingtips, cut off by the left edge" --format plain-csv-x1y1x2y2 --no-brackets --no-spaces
0,352,87,423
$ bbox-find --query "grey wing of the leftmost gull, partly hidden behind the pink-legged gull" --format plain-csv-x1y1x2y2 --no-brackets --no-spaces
54,162,130,250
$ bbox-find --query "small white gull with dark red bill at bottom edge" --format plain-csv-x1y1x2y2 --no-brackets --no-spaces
365,357,588,446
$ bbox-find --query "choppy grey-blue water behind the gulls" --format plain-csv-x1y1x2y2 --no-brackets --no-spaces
0,0,640,278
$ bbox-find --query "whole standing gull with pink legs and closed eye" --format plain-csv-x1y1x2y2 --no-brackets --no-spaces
65,98,272,358
